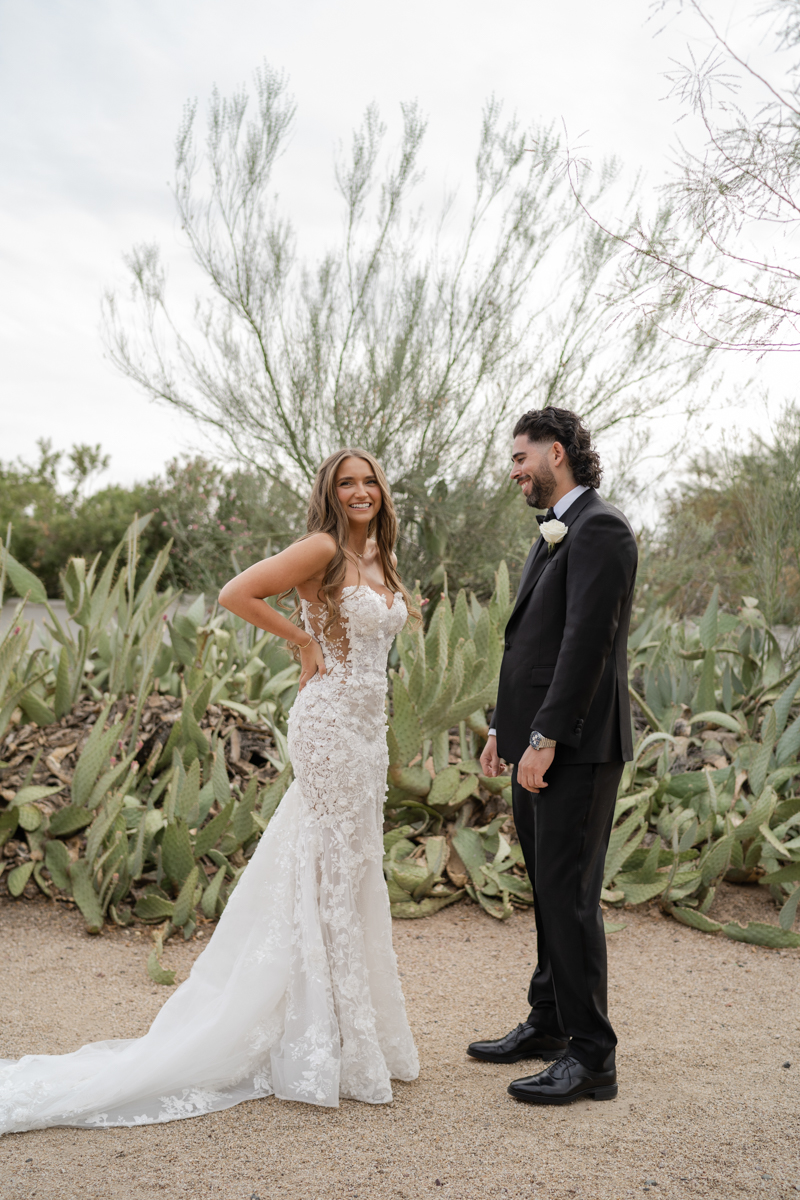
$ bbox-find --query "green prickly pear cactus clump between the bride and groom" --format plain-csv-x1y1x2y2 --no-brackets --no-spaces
384,564,533,918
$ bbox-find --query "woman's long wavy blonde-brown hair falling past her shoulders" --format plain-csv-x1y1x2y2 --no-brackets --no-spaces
282,446,420,634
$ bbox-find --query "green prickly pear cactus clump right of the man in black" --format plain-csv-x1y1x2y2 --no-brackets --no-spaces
603,590,800,947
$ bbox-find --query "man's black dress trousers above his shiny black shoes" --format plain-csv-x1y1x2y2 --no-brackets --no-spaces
512,751,624,1070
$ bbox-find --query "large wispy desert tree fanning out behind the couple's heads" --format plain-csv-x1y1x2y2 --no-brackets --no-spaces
104,66,704,590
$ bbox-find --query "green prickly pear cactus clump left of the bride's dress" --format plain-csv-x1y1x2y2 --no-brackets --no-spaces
0,513,297,983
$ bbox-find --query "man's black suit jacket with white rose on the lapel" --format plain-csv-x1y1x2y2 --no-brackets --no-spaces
493,490,638,763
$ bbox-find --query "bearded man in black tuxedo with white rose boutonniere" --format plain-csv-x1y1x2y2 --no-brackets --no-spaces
468,406,637,1104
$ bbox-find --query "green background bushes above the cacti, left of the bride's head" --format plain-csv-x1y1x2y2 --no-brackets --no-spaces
0,440,303,600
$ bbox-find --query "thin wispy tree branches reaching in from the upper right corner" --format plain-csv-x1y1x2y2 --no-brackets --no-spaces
571,0,800,354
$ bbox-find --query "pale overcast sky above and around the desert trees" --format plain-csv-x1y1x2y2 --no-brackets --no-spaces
0,0,787,492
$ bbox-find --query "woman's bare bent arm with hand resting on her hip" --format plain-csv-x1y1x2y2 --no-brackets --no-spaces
219,533,336,690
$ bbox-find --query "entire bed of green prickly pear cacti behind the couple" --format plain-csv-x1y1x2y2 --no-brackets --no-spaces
0,518,800,964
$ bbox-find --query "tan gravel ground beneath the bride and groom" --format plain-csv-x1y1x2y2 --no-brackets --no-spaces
0,888,800,1200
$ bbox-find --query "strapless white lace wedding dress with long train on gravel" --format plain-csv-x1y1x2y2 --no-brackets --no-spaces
0,586,419,1133
